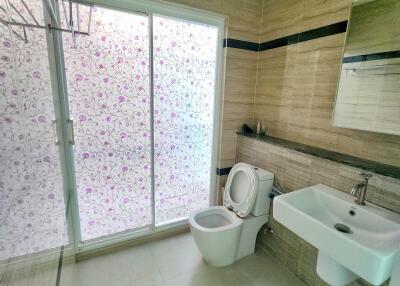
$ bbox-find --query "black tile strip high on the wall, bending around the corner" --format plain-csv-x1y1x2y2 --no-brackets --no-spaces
223,21,347,52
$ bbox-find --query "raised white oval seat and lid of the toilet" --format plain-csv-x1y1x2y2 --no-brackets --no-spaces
224,163,258,217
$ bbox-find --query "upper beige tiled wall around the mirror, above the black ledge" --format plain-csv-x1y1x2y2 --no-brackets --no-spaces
255,0,400,166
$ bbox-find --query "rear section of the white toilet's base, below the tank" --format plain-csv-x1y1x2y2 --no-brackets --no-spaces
235,215,268,261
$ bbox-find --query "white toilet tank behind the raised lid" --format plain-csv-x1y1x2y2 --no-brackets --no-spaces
251,167,274,216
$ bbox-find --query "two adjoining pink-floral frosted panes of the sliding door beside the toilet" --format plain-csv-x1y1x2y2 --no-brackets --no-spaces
61,7,218,242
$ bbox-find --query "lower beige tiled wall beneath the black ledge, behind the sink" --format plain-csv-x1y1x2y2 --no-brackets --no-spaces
236,136,400,285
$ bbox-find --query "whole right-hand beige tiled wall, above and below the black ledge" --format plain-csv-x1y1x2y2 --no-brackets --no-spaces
252,0,400,285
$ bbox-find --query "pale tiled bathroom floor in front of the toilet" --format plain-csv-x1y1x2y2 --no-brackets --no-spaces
0,233,305,286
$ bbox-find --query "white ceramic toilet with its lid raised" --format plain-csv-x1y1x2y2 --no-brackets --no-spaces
189,163,274,266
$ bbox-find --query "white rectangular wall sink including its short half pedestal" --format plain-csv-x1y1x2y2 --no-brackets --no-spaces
273,184,400,285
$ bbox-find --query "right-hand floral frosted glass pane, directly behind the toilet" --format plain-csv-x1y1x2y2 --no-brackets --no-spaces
153,16,218,224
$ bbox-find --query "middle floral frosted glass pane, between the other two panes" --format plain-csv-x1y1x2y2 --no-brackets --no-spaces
63,7,152,240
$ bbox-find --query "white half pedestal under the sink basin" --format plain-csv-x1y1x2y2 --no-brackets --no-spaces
317,250,358,286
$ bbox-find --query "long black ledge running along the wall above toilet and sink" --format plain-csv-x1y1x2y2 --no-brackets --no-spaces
237,133,400,179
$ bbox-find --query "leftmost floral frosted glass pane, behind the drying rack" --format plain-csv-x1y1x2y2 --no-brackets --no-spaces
0,0,68,260
